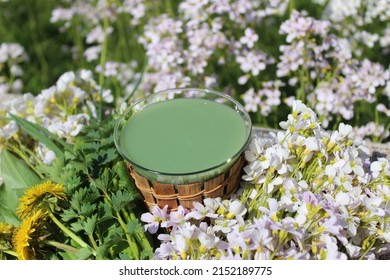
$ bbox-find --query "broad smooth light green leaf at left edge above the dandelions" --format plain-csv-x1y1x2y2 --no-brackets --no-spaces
0,150,40,225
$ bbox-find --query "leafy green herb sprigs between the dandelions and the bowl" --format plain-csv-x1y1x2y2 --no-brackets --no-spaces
34,118,153,259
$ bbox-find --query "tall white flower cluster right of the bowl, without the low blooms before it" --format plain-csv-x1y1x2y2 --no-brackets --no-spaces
243,101,390,259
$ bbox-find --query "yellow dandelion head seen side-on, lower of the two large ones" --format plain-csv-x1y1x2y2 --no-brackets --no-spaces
12,210,46,260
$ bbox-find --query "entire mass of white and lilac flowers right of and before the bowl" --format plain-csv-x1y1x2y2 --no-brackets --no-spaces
141,101,390,259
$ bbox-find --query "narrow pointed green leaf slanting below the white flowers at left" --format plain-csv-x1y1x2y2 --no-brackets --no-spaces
10,114,68,156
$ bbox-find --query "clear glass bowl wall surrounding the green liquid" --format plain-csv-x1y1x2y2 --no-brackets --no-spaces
114,88,252,184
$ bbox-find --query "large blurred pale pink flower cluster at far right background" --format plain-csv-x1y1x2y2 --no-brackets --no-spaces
277,12,390,132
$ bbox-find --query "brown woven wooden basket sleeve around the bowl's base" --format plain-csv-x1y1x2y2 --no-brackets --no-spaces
127,155,245,210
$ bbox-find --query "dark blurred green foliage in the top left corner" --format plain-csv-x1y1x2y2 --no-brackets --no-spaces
0,0,78,94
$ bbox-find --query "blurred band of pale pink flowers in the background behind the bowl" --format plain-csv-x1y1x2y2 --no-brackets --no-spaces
42,0,390,142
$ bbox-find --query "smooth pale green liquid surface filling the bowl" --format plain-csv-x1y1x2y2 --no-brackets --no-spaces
120,99,247,174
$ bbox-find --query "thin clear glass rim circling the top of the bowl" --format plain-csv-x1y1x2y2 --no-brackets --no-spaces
114,87,252,177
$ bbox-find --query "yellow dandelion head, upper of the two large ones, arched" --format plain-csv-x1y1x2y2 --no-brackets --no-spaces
17,181,66,218
